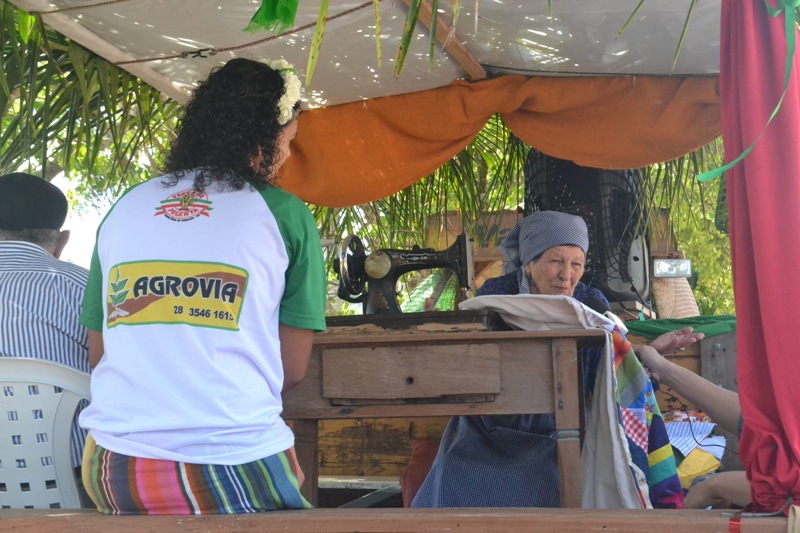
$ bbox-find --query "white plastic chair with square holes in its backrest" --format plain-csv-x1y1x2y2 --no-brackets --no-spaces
0,357,89,509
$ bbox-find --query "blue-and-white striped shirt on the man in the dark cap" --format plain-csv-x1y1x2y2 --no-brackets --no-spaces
0,241,90,466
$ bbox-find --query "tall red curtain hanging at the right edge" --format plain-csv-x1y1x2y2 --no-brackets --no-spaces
720,0,800,512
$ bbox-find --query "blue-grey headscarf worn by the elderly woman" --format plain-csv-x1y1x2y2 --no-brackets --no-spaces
500,211,589,294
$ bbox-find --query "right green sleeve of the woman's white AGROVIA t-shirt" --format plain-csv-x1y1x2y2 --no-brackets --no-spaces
261,187,327,331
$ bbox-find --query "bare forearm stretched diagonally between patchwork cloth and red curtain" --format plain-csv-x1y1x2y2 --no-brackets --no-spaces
634,345,742,434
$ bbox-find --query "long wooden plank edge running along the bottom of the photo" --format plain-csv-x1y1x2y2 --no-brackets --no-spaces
0,509,787,533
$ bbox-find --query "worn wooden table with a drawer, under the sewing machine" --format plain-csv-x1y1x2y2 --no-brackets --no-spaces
283,329,605,507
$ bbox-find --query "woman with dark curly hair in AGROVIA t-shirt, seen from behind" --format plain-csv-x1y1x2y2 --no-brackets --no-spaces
80,59,326,514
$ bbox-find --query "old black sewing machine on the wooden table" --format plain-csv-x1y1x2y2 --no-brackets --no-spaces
334,233,474,315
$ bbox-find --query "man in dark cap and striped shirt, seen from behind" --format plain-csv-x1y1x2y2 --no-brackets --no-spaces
0,172,90,502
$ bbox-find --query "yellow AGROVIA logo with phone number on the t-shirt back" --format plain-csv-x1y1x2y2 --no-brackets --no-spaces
106,261,247,331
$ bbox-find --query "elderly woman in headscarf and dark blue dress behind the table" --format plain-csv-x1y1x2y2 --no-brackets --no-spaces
411,211,696,507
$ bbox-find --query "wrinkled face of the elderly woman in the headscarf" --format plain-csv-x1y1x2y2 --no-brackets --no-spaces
525,246,586,296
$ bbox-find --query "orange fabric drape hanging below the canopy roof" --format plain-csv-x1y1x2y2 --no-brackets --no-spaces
282,76,721,207
